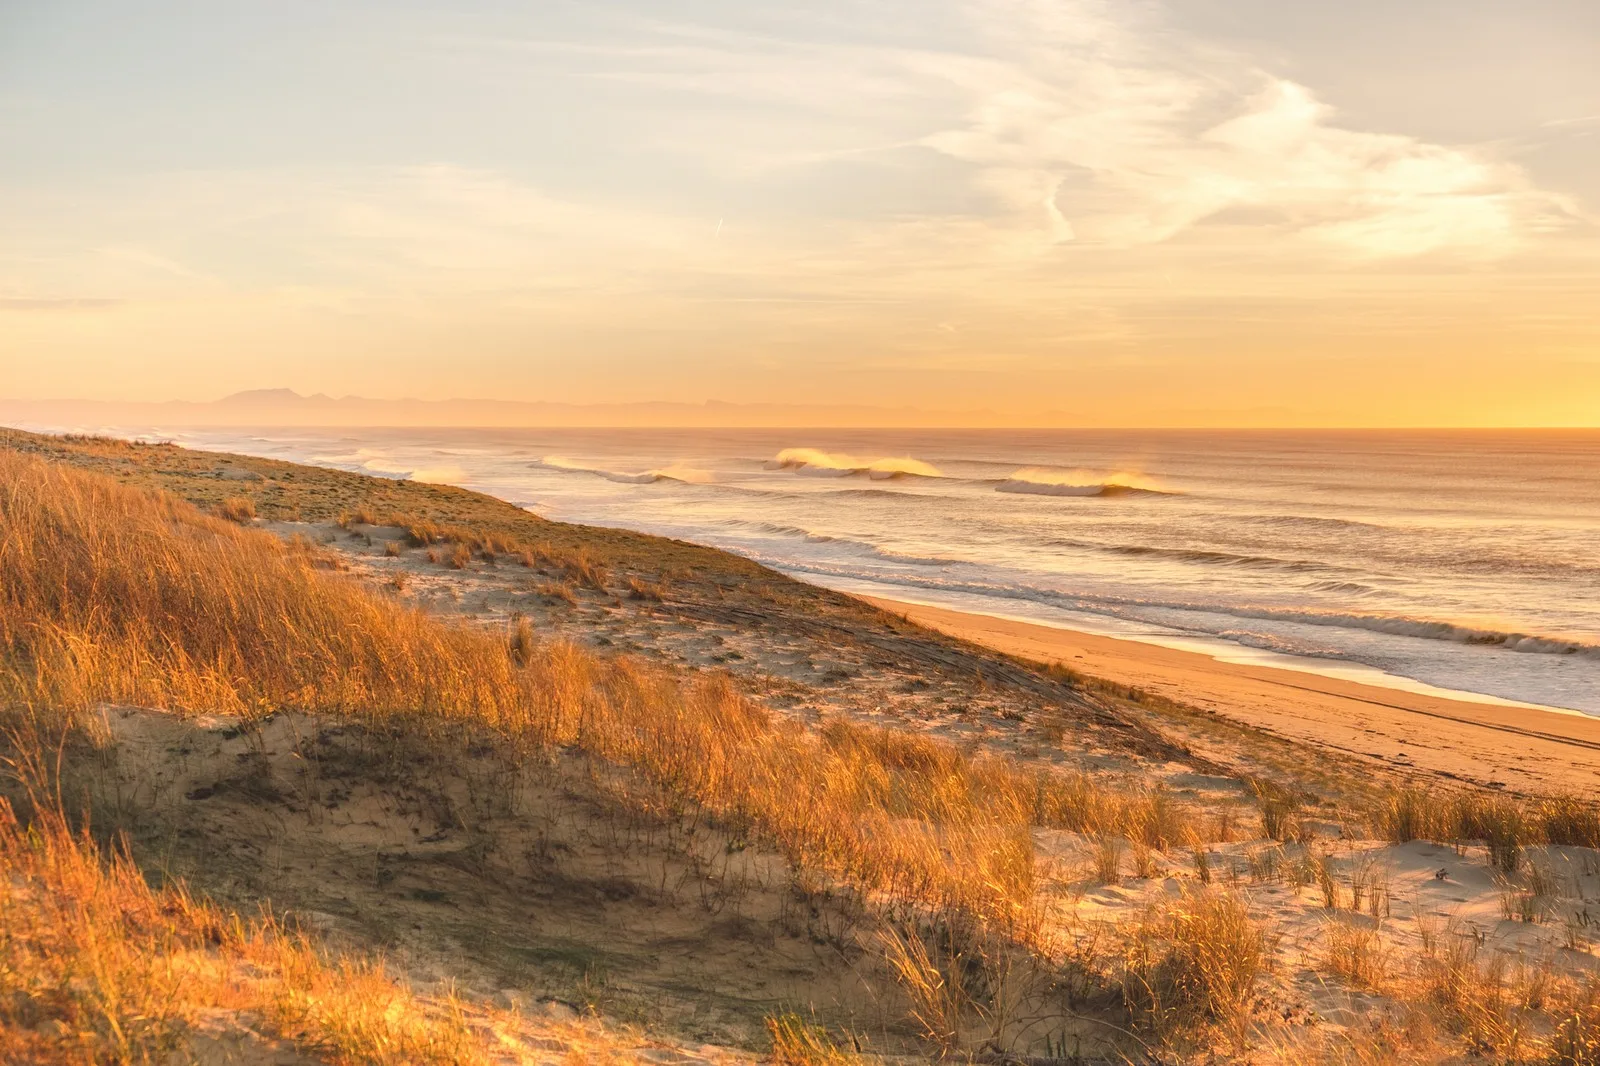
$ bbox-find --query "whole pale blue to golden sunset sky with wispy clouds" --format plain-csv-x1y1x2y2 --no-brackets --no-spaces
0,0,1600,426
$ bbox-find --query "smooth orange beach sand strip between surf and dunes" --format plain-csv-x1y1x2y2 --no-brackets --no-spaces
867,597,1600,794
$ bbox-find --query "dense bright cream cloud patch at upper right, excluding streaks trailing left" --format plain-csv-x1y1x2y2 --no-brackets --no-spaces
925,0,1576,258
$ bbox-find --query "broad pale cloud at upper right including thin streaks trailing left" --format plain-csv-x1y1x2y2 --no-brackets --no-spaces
464,0,1587,264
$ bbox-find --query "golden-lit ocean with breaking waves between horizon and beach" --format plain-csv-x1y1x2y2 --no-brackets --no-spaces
68,427,1600,714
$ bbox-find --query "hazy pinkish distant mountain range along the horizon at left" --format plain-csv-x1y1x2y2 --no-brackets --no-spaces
0,389,1024,429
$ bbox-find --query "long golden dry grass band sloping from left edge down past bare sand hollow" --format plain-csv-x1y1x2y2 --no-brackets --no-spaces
0,444,1170,960
